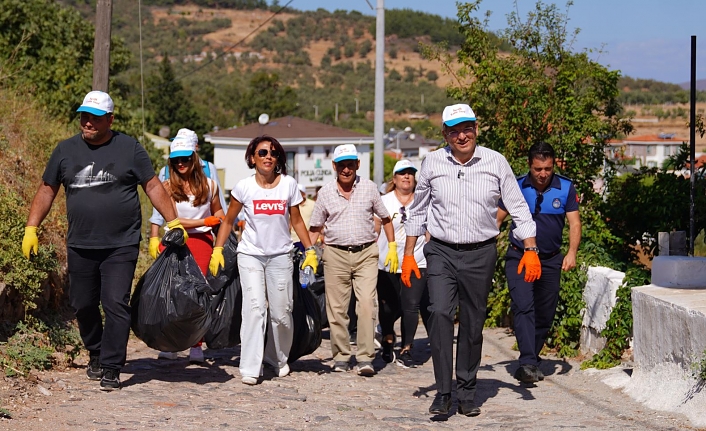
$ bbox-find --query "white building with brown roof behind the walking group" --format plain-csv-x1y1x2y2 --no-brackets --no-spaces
204,116,373,194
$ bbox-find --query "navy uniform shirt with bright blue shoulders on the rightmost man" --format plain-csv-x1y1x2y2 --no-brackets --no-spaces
498,174,579,253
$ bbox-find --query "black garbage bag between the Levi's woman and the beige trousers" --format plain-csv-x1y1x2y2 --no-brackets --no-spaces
287,251,321,363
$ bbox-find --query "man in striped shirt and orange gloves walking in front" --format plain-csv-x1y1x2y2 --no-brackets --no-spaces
401,104,541,416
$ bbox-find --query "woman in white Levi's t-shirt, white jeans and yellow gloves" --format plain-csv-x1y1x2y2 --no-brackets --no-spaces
209,135,317,385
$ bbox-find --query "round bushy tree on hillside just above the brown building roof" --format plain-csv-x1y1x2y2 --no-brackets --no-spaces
240,70,297,124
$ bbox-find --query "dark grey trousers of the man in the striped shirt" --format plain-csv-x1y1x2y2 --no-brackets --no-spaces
424,241,498,401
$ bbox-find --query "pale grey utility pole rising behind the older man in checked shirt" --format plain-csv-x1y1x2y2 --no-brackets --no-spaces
373,0,385,184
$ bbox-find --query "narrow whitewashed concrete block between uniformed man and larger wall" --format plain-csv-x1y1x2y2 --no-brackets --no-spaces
580,267,625,354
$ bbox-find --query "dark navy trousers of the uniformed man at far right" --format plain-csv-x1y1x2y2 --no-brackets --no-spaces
505,248,564,365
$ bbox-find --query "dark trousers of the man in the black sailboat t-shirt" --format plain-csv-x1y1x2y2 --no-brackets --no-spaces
67,245,139,370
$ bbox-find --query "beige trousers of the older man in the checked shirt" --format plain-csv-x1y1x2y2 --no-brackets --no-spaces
322,244,380,363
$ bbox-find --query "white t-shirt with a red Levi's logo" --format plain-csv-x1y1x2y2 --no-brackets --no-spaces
230,174,302,256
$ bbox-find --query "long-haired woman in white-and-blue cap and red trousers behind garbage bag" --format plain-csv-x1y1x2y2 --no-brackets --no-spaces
149,135,225,363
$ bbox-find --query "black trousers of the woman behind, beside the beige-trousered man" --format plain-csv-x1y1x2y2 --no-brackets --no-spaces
377,268,430,348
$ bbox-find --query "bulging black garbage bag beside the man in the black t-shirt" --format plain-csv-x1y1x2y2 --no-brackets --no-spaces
130,229,211,352
